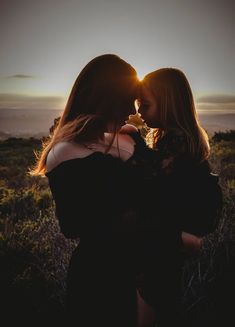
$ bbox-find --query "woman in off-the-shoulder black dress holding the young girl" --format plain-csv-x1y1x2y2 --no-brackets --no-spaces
32,54,143,327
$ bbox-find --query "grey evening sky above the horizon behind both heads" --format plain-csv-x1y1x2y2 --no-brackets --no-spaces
0,0,235,112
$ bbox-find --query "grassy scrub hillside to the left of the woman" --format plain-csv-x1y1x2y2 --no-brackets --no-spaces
0,138,76,322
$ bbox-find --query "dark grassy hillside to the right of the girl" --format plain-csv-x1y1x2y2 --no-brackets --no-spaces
182,130,235,327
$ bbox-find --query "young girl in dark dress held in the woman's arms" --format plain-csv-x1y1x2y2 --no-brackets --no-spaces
133,68,222,326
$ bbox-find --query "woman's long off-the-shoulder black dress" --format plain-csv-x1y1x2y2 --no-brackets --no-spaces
46,146,180,327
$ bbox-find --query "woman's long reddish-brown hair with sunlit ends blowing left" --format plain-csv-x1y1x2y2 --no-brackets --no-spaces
30,54,137,175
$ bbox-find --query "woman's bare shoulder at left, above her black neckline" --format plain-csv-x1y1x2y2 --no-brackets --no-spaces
46,142,92,172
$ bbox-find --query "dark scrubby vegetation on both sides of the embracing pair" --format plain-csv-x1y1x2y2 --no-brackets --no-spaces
0,131,235,327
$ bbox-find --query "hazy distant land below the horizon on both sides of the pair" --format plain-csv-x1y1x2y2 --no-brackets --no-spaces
0,109,235,140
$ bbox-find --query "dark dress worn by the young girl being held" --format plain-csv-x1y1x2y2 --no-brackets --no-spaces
132,130,223,236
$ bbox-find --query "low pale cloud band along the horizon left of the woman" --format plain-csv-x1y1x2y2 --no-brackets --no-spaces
0,93,65,109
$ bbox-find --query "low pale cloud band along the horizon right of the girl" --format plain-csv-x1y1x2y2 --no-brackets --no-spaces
196,94,235,112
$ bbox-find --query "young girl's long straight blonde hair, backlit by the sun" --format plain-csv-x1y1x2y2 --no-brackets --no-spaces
142,68,210,161
